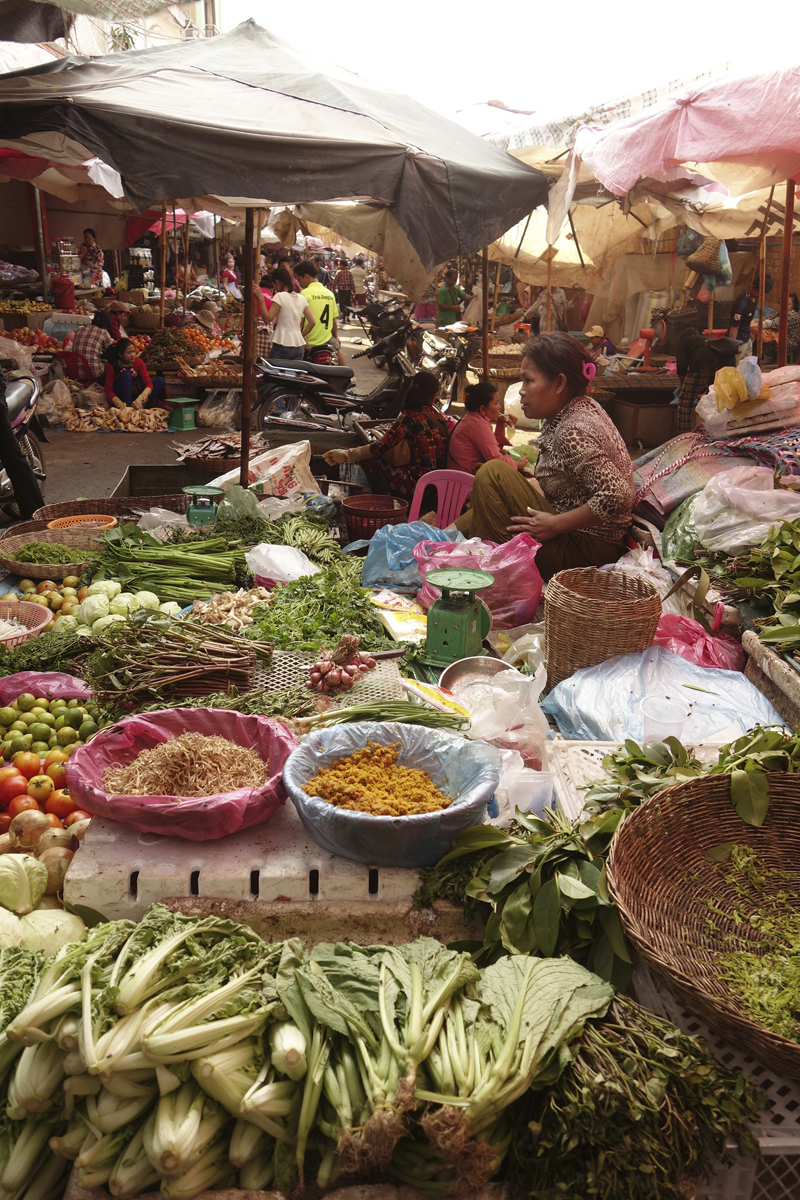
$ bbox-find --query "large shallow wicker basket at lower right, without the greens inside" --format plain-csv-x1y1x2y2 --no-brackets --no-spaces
607,773,800,1079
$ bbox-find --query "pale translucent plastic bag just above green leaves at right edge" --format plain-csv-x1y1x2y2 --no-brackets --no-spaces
694,467,800,554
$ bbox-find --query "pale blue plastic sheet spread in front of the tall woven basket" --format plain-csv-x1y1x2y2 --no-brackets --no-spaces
542,646,783,739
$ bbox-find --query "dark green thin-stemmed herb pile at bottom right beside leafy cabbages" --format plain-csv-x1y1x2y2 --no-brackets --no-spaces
512,997,764,1200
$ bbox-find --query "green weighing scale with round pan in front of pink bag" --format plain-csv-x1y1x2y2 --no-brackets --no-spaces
425,566,494,667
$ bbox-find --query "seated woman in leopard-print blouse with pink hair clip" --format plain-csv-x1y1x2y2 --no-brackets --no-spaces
456,332,633,580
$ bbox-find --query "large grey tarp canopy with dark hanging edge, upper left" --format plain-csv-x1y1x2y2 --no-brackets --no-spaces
0,20,548,270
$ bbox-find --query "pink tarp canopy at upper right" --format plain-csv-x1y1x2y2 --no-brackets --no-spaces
576,67,800,196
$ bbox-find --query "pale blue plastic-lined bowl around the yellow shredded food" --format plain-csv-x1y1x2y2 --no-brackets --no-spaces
281,721,500,866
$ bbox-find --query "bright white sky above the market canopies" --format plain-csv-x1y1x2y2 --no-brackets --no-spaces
217,0,800,132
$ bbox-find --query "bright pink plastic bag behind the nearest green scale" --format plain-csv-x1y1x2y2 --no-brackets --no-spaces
411,533,543,629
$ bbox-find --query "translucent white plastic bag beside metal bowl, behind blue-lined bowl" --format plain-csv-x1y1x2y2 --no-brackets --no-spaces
469,665,549,770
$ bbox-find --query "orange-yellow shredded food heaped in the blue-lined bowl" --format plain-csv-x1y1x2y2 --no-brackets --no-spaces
305,742,451,817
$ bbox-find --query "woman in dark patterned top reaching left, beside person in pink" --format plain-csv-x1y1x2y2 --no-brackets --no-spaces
323,371,453,501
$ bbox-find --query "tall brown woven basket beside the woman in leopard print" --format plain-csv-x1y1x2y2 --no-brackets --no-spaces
545,566,661,688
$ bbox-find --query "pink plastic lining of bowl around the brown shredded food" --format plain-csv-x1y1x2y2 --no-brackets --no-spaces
66,708,297,841
